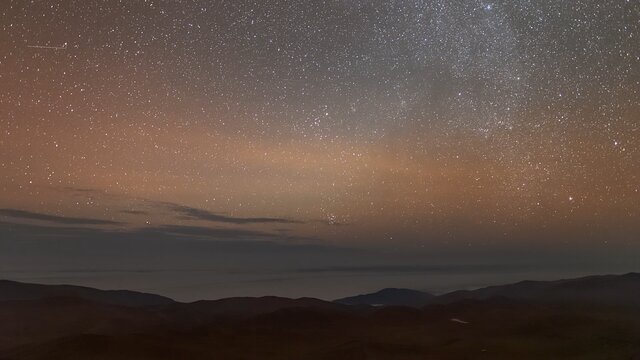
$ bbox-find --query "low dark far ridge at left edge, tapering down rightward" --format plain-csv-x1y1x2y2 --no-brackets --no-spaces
0,280,174,307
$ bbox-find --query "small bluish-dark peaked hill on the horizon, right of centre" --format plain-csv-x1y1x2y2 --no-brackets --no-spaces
334,288,434,307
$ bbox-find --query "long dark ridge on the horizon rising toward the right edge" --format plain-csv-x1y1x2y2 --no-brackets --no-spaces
430,273,640,307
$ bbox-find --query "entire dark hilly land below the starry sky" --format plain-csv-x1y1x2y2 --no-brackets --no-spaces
0,274,640,360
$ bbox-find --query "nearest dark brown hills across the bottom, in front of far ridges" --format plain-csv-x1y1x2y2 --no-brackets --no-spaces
0,300,640,360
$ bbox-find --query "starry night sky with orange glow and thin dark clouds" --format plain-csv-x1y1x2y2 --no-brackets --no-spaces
0,0,640,298
